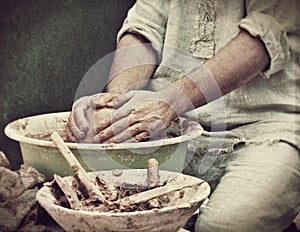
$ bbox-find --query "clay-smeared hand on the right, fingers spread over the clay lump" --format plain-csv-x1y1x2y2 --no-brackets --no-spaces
94,91,177,143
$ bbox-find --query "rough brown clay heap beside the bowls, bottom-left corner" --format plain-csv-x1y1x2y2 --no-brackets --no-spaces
0,152,50,232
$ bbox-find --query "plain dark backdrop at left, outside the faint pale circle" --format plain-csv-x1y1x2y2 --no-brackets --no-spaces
0,0,134,169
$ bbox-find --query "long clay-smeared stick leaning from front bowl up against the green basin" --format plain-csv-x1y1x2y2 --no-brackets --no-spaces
51,131,109,203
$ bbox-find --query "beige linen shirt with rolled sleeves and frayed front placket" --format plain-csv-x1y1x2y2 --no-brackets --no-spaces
118,0,300,149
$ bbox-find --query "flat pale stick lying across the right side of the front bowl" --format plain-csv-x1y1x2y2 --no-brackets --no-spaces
118,174,204,207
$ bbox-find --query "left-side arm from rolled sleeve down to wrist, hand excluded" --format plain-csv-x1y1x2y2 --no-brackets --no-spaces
106,0,169,93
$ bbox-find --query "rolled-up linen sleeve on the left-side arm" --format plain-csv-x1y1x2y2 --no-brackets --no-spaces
117,0,169,57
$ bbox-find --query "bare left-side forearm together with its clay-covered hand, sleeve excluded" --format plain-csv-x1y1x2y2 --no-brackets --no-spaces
67,33,157,142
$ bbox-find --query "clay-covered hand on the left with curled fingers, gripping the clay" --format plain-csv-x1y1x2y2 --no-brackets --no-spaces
67,93,119,142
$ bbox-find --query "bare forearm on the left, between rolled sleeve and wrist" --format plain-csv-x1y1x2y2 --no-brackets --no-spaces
106,33,157,94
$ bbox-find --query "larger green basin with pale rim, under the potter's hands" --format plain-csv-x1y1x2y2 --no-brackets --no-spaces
5,112,203,180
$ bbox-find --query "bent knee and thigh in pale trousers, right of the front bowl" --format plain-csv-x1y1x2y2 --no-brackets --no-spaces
196,142,300,232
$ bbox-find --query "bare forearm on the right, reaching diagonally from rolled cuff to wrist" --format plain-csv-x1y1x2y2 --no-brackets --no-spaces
164,31,270,113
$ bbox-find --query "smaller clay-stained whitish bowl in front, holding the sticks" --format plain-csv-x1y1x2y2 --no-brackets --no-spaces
37,169,210,232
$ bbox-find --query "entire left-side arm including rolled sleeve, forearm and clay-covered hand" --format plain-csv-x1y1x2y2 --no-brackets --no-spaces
67,0,169,141
